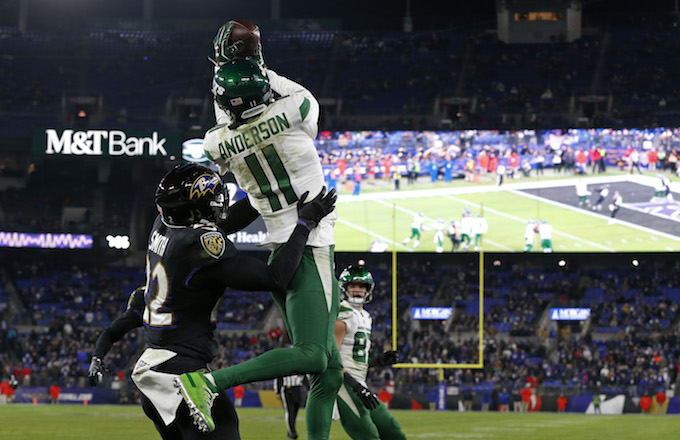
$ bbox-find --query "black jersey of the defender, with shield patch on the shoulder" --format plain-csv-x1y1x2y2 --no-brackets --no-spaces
144,216,238,363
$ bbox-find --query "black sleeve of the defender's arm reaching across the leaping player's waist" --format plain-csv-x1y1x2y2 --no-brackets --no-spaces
194,225,309,292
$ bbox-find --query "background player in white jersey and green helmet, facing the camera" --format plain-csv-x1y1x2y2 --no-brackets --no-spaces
335,265,406,440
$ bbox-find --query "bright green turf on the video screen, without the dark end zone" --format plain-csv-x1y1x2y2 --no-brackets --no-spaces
335,174,680,252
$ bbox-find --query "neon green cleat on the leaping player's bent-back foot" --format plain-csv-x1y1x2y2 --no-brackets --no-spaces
175,371,218,432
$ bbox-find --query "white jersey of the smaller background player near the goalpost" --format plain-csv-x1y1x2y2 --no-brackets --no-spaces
338,301,373,386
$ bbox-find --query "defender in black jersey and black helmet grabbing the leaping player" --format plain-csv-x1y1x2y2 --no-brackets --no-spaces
130,164,335,439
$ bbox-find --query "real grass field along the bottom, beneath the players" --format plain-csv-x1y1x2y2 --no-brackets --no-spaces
0,405,679,440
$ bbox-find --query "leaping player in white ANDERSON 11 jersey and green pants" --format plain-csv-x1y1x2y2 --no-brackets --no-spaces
181,58,342,440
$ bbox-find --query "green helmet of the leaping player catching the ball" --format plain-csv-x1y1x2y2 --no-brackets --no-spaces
212,58,273,121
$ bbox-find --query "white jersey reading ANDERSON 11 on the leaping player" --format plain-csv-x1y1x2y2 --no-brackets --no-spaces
203,70,337,248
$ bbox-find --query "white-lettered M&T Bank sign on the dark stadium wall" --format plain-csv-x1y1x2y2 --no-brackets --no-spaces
33,128,180,157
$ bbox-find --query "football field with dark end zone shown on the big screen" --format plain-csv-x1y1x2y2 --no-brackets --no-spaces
335,175,680,252
